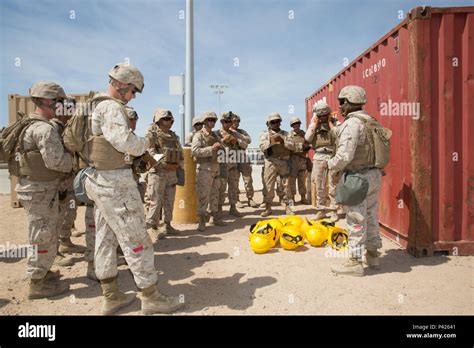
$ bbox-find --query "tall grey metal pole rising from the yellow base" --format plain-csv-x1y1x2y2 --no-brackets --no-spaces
184,0,194,134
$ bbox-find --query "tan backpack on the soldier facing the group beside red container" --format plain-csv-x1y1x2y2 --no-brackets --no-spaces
352,115,392,169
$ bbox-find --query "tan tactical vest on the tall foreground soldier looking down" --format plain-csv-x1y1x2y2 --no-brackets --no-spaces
87,101,134,170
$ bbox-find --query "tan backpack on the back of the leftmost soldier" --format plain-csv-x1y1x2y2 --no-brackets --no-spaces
0,111,49,175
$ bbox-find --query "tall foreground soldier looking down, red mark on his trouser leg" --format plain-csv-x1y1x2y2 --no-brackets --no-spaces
85,63,183,315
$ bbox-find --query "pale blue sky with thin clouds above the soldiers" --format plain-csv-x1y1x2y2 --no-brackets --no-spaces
0,0,473,147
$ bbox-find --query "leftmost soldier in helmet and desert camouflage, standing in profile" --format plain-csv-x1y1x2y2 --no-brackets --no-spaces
15,81,72,299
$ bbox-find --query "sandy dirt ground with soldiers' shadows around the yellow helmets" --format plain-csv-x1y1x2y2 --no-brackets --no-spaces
0,195,474,315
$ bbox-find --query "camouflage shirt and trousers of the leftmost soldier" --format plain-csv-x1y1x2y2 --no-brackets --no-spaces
15,113,72,279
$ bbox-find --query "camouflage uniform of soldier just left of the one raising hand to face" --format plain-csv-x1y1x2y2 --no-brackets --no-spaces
289,125,308,204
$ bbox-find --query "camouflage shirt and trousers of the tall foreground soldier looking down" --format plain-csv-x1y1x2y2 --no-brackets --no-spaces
81,100,157,289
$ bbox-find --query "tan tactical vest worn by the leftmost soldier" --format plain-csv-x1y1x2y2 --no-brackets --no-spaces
11,115,61,182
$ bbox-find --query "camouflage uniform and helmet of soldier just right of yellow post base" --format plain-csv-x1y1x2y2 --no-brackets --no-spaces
191,112,220,228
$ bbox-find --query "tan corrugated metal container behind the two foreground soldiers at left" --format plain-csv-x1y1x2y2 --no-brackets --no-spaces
8,93,89,208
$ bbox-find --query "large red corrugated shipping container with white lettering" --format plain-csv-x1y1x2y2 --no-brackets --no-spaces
306,7,474,256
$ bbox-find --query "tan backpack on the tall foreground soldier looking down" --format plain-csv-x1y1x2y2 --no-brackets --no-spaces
63,91,116,167
